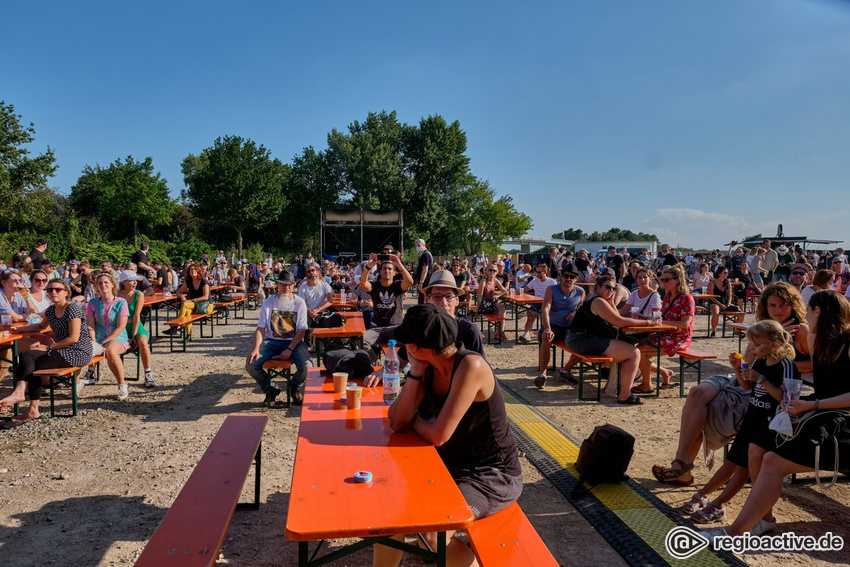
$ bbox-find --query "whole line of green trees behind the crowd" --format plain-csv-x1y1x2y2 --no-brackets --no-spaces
0,101,532,261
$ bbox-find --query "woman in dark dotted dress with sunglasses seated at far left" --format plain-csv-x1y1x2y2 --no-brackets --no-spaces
0,280,92,423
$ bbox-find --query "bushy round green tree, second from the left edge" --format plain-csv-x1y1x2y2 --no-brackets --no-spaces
71,156,177,246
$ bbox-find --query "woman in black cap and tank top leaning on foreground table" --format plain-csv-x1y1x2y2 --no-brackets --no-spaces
374,304,522,565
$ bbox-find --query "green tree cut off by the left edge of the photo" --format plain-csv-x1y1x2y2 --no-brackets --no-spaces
0,101,58,232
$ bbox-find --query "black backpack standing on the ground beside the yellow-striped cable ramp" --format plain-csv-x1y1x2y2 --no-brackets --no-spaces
573,423,635,497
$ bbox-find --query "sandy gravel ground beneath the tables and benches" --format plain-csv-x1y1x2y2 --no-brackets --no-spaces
0,302,850,567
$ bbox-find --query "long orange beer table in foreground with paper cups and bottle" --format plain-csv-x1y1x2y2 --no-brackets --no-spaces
286,368,474,566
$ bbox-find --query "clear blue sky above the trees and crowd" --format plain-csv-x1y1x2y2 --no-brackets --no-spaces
6,0,850,248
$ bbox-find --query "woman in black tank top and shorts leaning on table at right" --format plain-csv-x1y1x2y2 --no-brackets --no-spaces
564,275,652,405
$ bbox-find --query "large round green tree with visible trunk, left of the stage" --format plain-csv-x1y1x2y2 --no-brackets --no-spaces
183,136,288,254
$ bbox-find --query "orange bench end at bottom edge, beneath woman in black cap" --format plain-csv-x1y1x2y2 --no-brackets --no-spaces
466,502,558,567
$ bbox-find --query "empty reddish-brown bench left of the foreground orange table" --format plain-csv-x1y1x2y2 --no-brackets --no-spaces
136,414,268,567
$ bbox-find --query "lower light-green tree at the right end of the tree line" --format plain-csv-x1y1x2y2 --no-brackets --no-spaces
450,180,533,256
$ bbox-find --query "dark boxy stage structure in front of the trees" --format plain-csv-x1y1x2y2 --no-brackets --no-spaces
319,209,404,263
